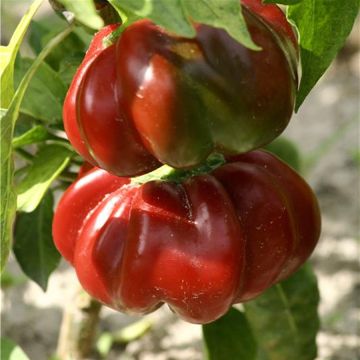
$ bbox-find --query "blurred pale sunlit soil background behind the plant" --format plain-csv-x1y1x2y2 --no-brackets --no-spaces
1,0,360,360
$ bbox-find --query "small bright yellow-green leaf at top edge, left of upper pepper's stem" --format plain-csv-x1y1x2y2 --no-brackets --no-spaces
58,0,104,30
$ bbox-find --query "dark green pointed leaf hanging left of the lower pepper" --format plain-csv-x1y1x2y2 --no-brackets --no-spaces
13,191,61,291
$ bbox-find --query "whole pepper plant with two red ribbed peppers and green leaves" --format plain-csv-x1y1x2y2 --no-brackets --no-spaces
0,0,359,360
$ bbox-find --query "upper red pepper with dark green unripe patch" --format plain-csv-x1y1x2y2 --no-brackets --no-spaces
64,0,298,176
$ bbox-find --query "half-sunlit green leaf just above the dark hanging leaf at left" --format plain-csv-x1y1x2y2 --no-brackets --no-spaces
16,145,72,212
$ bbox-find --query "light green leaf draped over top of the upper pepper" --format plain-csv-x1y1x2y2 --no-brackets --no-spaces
109,0,259,49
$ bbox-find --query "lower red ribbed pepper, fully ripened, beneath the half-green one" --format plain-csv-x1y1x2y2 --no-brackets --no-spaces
53,151,320,323
